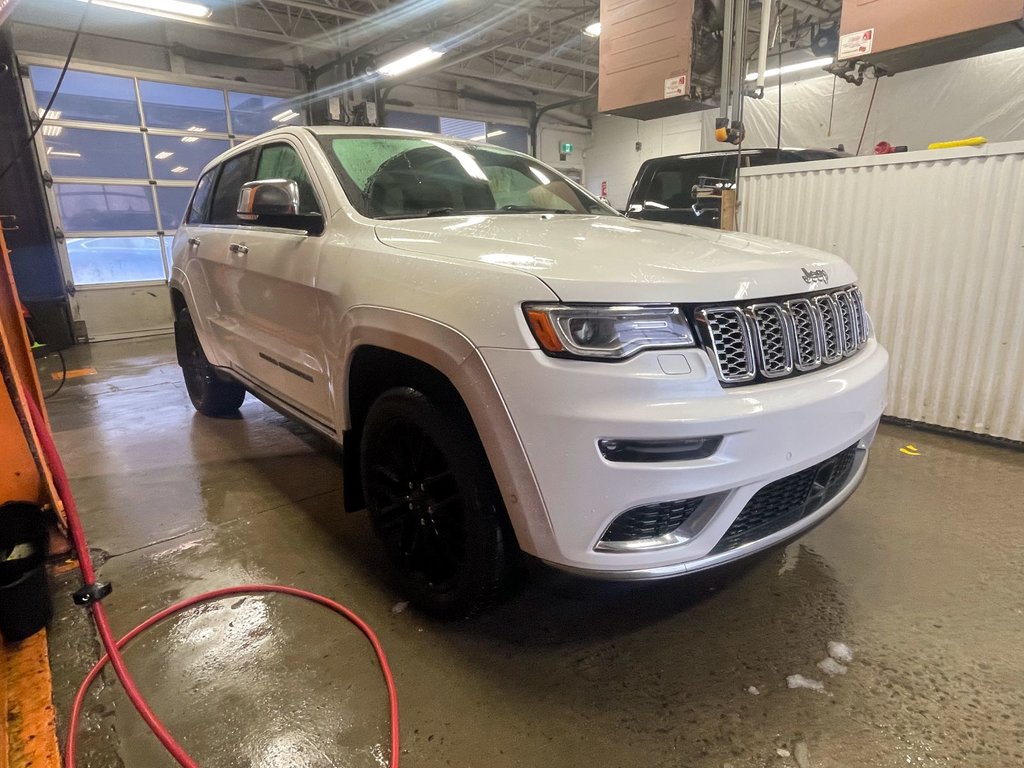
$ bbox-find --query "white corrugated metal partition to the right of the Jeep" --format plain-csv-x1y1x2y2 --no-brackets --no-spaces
740,142,1024,440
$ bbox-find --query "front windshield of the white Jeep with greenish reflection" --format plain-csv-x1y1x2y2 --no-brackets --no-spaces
318,136,616,219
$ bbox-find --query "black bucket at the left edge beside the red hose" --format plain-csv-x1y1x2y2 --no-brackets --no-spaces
0,502,53,643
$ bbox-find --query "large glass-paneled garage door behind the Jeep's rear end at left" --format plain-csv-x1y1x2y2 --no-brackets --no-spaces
26,62,301,340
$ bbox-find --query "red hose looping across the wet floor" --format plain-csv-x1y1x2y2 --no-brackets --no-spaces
25,396,398,768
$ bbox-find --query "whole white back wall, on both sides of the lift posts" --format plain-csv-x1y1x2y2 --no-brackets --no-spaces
585,48,1024,208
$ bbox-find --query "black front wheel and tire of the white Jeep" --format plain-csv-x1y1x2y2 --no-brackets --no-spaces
360,387,518,618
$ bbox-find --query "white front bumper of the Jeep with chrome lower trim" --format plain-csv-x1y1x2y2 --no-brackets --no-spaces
480,340,888,579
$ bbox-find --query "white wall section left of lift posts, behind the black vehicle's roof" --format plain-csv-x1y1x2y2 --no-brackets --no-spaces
584,113,701,209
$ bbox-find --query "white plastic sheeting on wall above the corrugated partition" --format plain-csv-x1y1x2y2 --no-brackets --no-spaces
701,48,1024,155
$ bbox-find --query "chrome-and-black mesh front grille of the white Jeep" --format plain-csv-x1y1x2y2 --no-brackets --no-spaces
694,286,869,384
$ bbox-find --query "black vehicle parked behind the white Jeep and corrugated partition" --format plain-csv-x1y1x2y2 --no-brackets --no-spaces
626,148,849,227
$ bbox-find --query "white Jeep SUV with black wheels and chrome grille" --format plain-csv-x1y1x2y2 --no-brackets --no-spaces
171,128,888,616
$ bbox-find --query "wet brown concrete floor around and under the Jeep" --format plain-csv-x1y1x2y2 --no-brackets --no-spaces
49,337,1024,768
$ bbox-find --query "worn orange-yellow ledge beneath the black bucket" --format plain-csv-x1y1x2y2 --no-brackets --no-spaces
0,630,60,768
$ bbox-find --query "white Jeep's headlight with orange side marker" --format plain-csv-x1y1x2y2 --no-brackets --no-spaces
523,304,696,360
